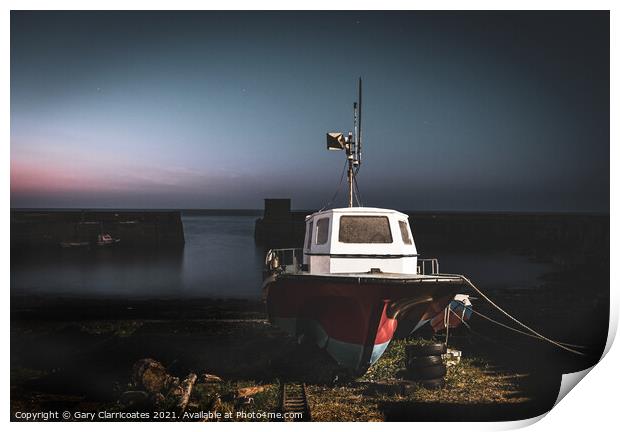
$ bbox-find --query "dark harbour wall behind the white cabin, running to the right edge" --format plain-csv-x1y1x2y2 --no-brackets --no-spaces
255,200,609,264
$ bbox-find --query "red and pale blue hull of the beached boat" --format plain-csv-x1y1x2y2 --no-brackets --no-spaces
266,273,462,372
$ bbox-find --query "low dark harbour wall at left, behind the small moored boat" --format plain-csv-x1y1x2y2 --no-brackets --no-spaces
11,210,185,251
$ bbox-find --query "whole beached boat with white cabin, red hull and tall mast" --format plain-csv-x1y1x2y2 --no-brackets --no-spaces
263,78,464,374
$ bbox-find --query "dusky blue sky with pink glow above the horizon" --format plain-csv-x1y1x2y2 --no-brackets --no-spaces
11,11,610,212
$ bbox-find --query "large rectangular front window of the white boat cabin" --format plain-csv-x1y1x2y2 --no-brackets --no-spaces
338,216,392,243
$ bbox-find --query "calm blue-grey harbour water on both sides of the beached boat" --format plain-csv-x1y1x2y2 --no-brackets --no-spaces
11,215,550,299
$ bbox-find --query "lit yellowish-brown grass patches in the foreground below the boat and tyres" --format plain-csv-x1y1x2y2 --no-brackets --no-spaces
180,339,526,422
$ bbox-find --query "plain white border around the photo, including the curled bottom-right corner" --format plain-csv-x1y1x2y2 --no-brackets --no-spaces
0,0,620,431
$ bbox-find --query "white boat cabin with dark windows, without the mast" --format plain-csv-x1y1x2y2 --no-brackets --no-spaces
303,207,418,274
